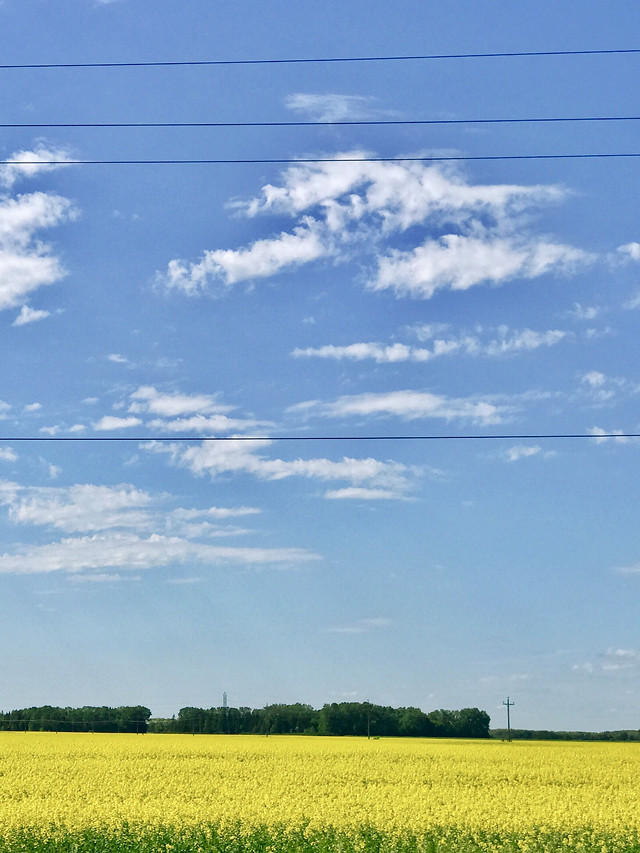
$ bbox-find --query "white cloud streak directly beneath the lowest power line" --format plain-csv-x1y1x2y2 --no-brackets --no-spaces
143,439,418,498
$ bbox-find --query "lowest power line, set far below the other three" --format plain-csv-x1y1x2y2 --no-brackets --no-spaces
0,432,640,443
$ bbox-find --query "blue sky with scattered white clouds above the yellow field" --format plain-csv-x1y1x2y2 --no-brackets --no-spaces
0,0,640,730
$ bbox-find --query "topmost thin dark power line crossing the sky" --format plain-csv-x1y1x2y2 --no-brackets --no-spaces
0,48,640,70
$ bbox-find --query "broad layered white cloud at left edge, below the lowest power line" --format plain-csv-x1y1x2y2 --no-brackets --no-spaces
0,481,319,580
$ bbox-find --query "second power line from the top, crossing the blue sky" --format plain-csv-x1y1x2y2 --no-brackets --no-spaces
0,116,640,129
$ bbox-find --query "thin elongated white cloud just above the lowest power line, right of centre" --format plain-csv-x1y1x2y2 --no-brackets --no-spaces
289,391,506,425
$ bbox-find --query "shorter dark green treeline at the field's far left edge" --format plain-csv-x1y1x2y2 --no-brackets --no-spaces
0,705,151,734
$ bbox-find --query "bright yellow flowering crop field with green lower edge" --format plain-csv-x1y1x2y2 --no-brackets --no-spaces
0,732,640,853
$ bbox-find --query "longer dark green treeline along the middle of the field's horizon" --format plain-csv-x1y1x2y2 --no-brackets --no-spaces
149,702,490,738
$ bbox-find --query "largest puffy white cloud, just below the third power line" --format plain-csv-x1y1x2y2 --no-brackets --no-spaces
158,153,591,299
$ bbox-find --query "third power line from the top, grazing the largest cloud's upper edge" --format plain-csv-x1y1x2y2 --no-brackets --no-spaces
0,151,640,166
